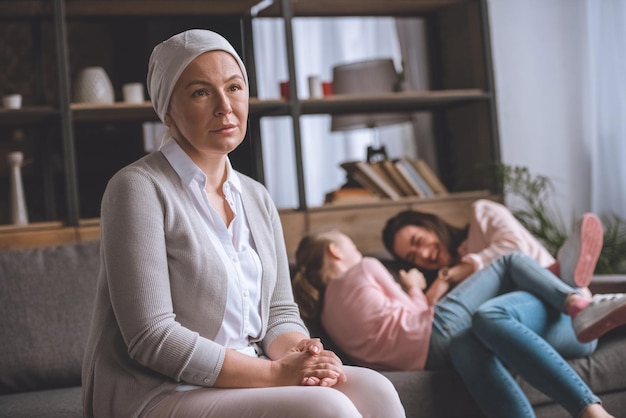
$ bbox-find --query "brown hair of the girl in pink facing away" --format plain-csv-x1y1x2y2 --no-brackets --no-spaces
293,233,333,319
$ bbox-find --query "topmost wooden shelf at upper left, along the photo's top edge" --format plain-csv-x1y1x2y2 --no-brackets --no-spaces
0,0,259,18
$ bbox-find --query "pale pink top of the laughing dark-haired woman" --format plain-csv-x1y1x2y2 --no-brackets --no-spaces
459,199,554,271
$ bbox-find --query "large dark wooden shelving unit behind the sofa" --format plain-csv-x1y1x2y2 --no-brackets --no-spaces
0,0,500,256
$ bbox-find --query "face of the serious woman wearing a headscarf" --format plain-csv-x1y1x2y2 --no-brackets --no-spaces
165,51,249,159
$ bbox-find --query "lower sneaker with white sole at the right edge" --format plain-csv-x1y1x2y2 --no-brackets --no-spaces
572,293,626,343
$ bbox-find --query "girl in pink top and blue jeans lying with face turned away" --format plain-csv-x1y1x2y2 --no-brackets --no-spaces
294,231,626,417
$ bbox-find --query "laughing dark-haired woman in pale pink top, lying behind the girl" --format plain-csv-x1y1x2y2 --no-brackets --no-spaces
383,199,603,296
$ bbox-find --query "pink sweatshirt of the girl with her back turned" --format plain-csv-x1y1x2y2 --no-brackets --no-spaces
322,257,433,370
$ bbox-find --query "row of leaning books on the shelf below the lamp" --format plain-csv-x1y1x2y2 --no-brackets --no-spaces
327,157,448,202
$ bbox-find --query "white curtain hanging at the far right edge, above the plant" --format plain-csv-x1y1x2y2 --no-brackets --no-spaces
583,0,626,219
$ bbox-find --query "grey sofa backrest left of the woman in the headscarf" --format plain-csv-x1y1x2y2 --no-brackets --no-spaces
0,241,100,394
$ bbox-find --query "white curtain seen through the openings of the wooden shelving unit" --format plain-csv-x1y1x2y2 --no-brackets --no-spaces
253,17,415,208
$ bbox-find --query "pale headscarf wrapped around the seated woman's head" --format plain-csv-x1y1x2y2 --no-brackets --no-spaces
146,29,248,122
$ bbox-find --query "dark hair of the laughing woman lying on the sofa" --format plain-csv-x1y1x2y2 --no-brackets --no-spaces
383,210,468,260
